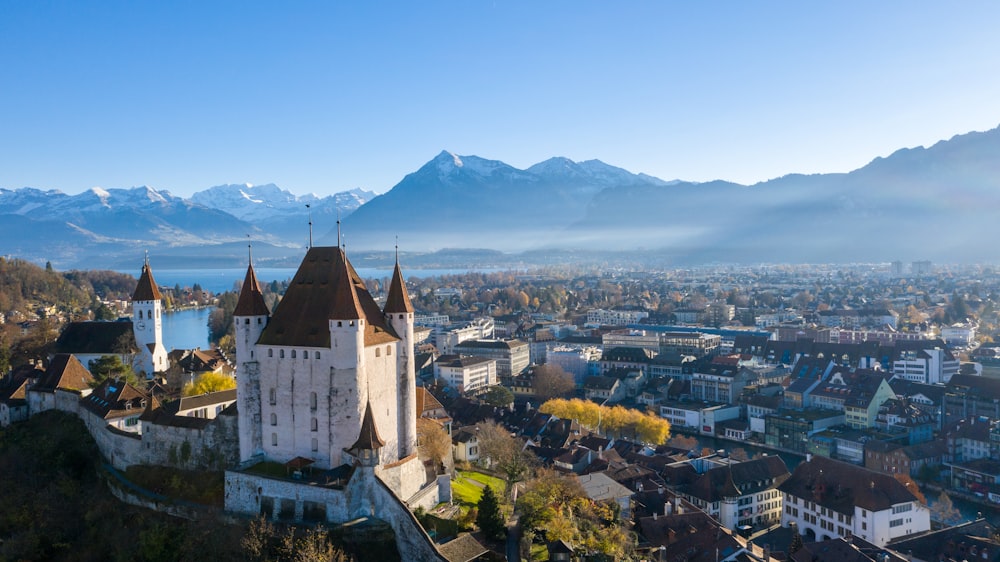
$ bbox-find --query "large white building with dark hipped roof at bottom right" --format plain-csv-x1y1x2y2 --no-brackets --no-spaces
778,455,931,547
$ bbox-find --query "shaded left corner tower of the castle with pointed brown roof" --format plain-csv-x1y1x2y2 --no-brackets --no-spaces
233,258,271,460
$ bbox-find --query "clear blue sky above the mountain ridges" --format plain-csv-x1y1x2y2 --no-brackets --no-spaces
0,0,1000,196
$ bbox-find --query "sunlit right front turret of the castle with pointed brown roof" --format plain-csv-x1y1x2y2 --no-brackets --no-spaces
383,258,417,458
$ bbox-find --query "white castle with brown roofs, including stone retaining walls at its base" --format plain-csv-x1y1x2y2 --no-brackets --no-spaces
226,247,439,556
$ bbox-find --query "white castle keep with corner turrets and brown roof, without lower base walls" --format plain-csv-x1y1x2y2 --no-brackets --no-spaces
234,247,419,472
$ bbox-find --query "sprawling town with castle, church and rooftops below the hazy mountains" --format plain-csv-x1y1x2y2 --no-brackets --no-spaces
0,255,1000,562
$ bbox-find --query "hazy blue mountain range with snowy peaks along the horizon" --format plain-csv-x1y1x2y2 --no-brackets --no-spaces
0,124,1000,267
